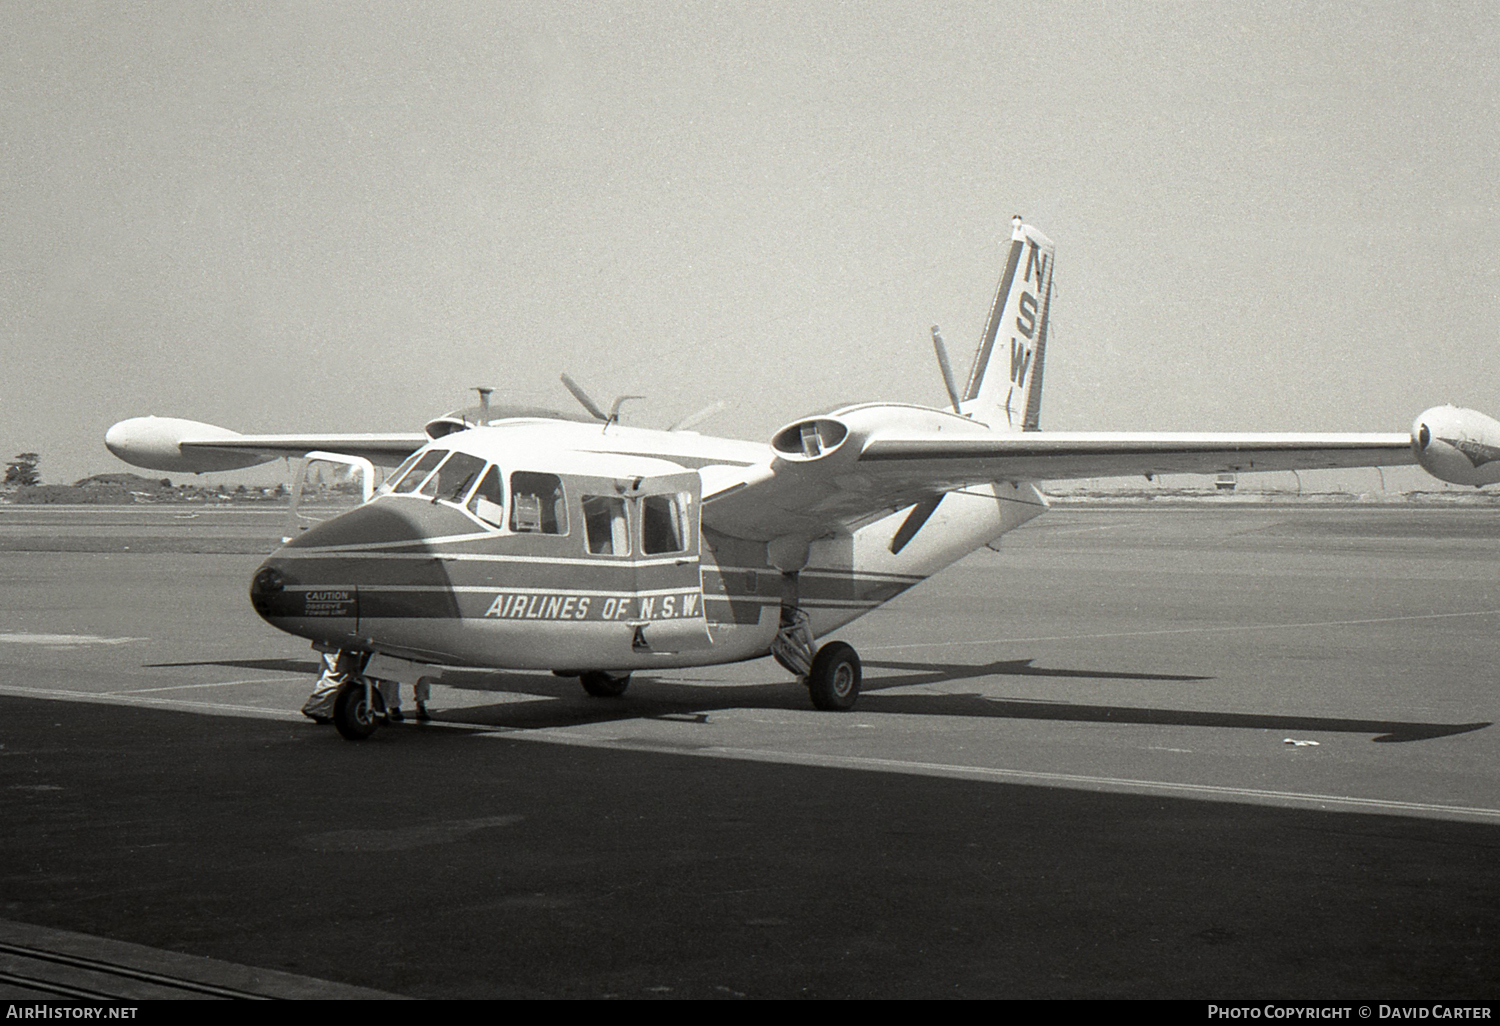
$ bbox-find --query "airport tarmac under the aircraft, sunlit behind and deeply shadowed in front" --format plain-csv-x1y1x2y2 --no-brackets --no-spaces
0,506,1500,1001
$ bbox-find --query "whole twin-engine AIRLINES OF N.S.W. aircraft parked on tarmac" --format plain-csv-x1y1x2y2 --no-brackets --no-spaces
105,218,1500,738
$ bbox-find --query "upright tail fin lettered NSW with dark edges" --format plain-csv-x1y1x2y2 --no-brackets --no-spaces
962,218,1053,431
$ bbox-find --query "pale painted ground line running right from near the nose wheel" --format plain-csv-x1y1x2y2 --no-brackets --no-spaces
489,731,1500,822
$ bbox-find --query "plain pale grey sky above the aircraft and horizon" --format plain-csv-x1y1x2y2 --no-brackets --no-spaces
0,0,1500,482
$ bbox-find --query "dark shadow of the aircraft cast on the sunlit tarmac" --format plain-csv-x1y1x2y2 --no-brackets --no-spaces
193,659,1493,743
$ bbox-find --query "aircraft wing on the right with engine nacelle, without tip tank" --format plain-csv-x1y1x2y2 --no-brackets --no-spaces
704,405,1418,540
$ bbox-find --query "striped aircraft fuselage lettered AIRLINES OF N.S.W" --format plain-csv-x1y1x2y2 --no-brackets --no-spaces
251,411,1046,672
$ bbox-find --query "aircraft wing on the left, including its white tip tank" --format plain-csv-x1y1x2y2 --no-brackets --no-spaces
104,417,431,474
